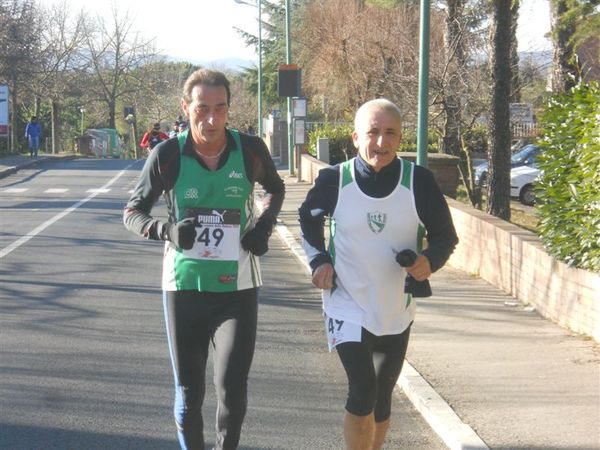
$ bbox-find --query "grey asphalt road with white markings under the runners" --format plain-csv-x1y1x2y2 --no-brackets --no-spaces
0,159,445,450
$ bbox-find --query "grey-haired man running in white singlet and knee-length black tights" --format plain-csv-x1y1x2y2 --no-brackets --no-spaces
299,99,458,450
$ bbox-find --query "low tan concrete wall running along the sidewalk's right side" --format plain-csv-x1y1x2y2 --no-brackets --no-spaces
302,155,600,342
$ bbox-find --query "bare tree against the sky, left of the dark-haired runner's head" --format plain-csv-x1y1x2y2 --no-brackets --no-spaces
86,6,156,128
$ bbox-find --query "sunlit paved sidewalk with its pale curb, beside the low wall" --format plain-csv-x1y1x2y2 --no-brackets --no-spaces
277,171,600,450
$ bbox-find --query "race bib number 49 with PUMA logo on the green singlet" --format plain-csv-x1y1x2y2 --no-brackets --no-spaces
183,208,241,261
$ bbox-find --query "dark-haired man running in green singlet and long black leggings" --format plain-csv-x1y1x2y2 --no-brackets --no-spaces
124,69,285,450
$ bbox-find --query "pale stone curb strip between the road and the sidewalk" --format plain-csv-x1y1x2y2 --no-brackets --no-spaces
255,193,489,450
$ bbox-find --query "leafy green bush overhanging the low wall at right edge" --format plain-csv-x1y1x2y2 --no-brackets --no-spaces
536,83,600,272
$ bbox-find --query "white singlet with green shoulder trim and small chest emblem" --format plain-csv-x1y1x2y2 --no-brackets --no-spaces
323,159,425,336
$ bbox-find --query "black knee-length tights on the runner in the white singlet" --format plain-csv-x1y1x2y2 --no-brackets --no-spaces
336,326,410,422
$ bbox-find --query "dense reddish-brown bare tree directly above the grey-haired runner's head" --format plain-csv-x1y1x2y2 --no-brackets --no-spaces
297,0,426,121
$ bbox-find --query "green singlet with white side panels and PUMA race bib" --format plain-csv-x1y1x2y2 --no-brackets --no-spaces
162,130,262,292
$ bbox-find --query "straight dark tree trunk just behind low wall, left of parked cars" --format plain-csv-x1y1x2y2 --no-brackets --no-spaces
487,0,512,220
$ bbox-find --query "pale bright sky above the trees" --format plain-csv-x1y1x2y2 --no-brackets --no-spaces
38,0,551,63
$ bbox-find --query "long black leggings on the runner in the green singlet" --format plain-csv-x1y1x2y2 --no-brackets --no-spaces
164,289,257,450
